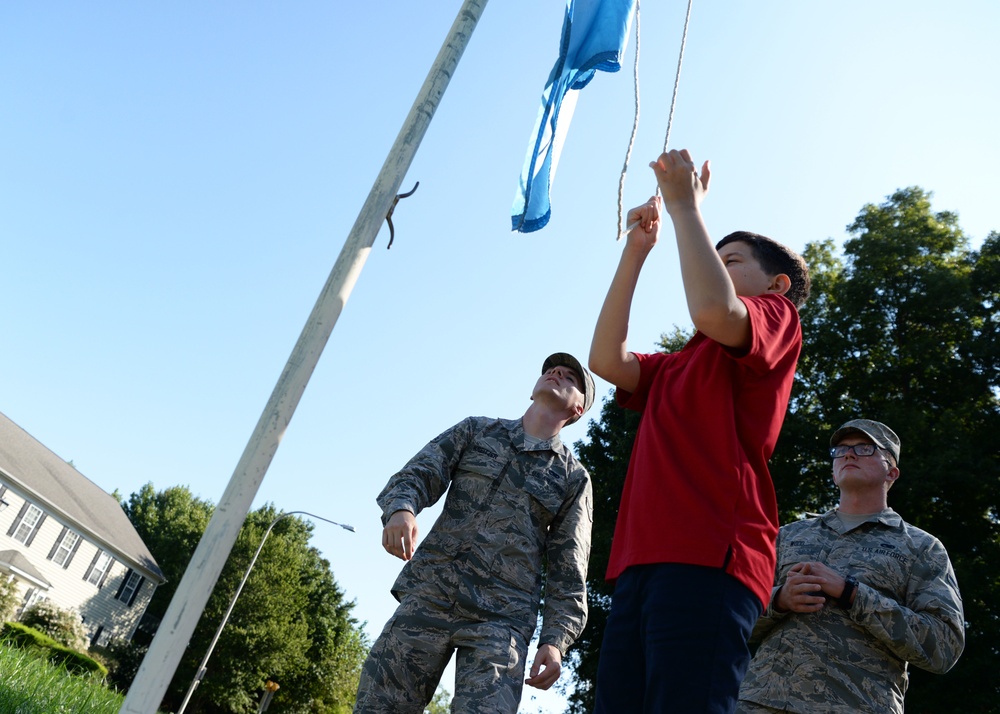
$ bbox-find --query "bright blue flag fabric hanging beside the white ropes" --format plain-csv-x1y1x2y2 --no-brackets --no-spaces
511,0,635,233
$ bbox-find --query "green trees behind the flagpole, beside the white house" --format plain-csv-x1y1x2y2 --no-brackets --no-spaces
119,485,368,714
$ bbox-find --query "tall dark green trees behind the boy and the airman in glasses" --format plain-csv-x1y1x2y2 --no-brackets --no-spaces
570,187,1000,713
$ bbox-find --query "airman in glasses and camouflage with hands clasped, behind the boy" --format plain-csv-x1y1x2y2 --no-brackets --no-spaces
737,419,965,714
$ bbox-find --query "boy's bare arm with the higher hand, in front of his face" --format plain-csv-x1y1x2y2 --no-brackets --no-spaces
650,149,750,347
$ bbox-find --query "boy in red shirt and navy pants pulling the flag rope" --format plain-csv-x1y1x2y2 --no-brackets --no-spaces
590,150,809,714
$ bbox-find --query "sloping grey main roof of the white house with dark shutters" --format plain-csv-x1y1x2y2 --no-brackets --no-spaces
0,413,166,584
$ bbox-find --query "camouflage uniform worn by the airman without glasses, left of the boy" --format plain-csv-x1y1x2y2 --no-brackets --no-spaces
354,417,593,714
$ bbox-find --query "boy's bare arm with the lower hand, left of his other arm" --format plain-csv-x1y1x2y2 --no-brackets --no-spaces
589,196,662,392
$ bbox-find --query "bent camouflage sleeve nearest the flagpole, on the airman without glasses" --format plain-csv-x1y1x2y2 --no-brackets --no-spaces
375,417,474,525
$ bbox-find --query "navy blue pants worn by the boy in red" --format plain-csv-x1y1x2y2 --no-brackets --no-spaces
594,563,761,714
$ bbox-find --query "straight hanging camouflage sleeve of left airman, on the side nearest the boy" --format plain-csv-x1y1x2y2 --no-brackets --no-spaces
538,465,594,654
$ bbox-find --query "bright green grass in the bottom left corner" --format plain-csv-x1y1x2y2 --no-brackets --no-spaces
0,644,124,714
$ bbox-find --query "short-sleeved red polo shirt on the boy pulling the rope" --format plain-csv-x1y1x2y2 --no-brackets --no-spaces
607,295,802,607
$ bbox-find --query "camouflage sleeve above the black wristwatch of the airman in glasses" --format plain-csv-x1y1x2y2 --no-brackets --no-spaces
848,538,965,674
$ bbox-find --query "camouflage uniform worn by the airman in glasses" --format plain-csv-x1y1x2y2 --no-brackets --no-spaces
737,508,965,714
